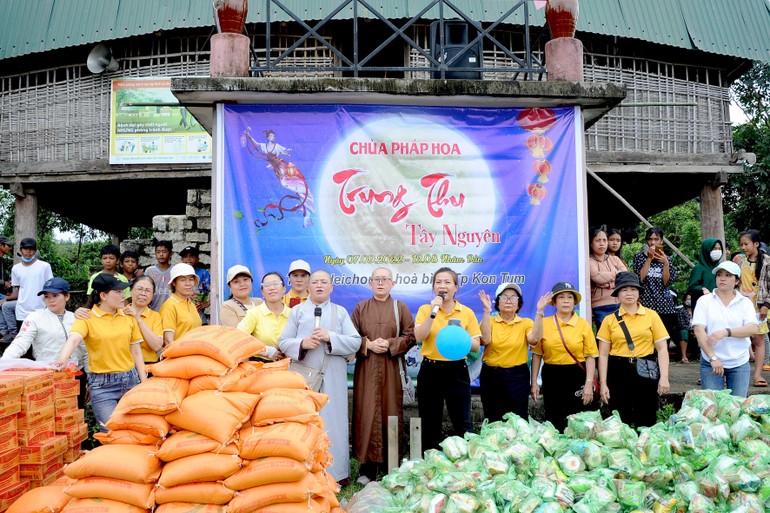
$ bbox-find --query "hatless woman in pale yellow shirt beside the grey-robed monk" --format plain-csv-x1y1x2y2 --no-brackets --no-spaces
238,272,291,359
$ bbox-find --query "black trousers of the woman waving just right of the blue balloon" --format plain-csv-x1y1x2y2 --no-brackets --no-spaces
480,363,530,422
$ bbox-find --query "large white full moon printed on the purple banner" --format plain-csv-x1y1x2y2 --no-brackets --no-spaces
317,115,498,291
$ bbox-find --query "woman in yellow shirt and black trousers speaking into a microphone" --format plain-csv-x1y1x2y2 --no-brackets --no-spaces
414,267,481,450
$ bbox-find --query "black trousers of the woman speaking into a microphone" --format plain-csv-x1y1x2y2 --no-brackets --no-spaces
417,358,472,451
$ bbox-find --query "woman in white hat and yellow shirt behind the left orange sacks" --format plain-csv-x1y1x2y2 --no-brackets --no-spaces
160,264,202,345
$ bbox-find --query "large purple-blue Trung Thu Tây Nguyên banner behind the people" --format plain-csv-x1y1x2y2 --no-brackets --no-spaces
216,105,589,316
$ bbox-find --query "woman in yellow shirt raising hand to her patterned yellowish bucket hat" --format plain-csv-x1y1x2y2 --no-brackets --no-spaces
531,282,599,431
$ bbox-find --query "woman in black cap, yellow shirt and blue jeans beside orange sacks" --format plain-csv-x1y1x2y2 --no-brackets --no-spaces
53,273,147,431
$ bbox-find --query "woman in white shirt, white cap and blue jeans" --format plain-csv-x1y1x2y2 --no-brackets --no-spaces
692,261,759,397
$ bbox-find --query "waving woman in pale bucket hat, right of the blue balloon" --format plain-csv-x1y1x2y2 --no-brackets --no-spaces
479,283,546,422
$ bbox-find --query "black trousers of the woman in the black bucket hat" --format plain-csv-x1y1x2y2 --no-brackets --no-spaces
607,353,659,427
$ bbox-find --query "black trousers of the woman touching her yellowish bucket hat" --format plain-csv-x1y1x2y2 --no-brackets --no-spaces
541,363,591,433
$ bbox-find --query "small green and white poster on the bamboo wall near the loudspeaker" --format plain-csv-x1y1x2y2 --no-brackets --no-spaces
110,78,211,164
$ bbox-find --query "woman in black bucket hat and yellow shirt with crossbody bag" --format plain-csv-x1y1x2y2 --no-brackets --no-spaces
596,273,671,427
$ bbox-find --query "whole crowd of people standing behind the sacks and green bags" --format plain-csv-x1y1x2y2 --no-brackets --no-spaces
0,227,770,484
